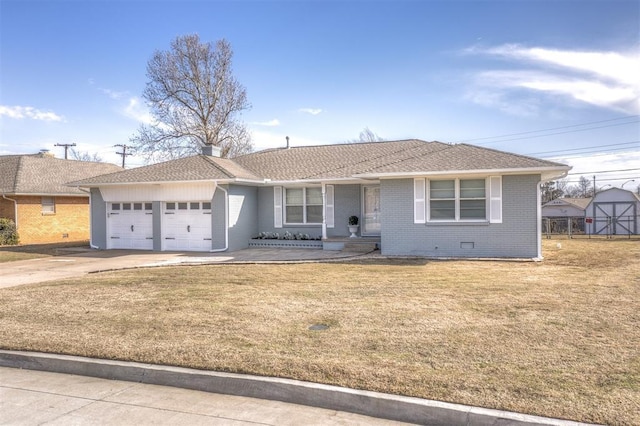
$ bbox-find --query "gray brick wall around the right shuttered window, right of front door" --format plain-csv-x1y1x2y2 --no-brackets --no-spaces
380,175,540,258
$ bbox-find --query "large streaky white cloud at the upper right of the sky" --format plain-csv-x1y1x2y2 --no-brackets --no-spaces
465,45,640,114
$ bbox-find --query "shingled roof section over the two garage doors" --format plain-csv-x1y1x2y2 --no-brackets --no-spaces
71,155,262,186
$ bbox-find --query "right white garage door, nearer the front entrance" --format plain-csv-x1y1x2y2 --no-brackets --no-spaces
162,201,211,251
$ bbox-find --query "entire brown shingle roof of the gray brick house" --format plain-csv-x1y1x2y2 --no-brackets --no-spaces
74,139,569,186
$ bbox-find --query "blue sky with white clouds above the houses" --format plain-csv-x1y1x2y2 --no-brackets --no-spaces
0,0,640,189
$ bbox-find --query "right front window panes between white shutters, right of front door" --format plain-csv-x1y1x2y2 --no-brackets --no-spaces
429,179,487,221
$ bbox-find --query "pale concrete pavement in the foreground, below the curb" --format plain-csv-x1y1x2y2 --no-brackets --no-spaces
0,367,402,426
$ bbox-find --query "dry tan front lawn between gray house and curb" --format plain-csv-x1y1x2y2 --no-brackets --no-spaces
0,239,640,425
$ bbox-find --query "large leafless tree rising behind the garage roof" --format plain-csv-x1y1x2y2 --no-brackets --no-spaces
130,35,252,161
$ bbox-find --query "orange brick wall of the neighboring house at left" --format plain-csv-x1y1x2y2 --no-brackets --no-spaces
13,196,89,244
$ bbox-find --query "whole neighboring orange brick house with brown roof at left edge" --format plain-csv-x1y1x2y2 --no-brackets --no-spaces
0,153,122,244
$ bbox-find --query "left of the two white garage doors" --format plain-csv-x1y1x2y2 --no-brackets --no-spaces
107,203,153,250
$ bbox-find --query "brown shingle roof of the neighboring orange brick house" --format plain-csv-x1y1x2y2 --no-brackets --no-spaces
0,154,122,195
